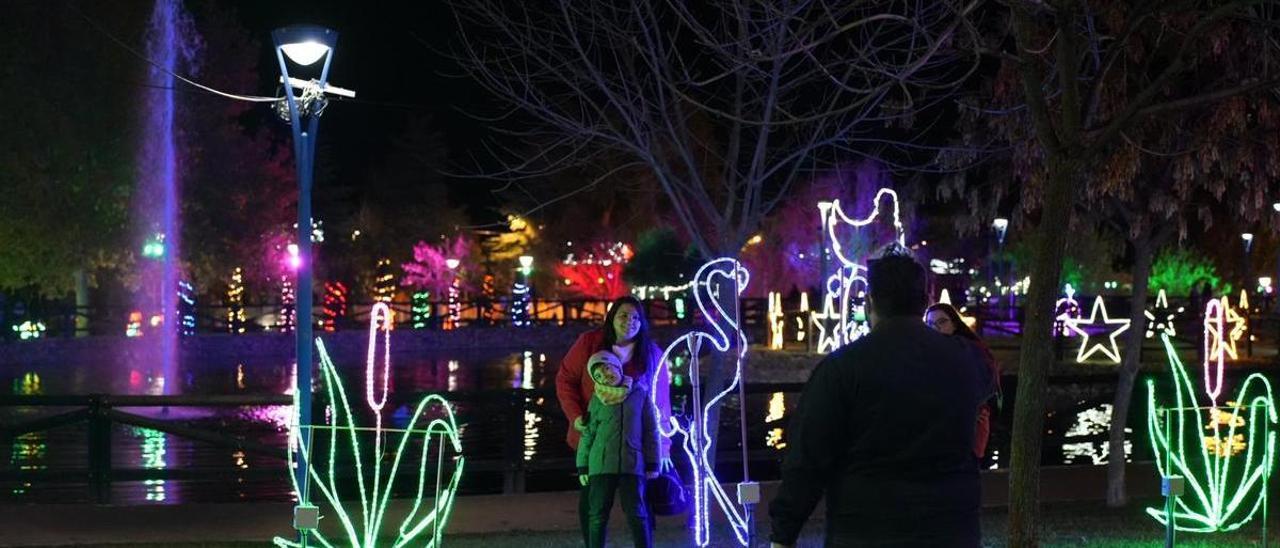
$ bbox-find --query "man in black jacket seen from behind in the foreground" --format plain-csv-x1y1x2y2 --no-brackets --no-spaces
769,255,993,547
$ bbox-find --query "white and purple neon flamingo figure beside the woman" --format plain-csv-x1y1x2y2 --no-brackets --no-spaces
650,259,750,547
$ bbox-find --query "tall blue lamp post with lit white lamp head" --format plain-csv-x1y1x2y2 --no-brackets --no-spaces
271,26,338,514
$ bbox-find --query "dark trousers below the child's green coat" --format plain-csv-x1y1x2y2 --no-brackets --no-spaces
579,474,653,548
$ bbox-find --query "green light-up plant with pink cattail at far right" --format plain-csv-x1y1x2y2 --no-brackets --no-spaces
1147,300,1280,533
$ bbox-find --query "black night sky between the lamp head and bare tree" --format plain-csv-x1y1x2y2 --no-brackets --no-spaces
227,0,494,222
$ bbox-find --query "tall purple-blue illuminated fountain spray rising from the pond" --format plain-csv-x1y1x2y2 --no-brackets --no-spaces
133,0,198,391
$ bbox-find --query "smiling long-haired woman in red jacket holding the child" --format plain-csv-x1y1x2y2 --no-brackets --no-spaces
556,296,672,542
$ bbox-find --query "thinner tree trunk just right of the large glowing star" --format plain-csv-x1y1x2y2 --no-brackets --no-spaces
1107,236,1158,508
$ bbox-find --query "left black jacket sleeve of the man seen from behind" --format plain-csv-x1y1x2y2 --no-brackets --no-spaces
769,357,849,545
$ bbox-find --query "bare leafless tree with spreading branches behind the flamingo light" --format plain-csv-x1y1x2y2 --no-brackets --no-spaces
453,0,978,460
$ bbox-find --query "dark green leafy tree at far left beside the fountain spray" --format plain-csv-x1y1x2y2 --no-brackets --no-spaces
0,3,148,306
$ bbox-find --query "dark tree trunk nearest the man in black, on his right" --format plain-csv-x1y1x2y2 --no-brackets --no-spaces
1009,157,1082,548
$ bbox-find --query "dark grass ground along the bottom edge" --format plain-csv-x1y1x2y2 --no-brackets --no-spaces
22,501,1280,548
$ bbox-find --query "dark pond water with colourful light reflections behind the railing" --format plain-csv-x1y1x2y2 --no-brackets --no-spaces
0,348,1235,503
